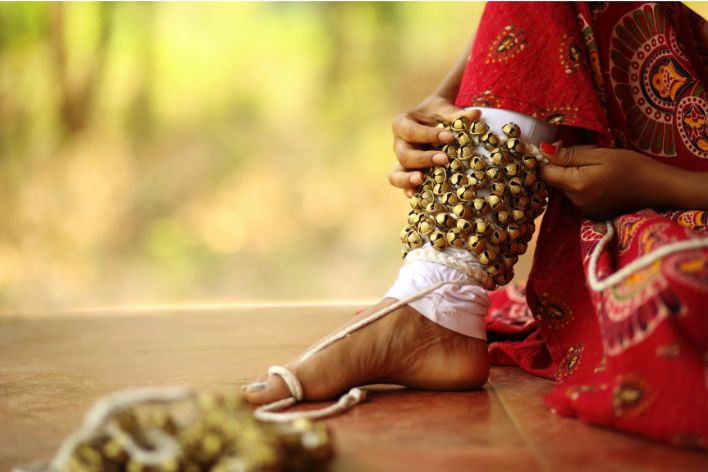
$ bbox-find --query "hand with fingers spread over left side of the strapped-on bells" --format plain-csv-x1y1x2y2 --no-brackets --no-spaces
388,95,480,196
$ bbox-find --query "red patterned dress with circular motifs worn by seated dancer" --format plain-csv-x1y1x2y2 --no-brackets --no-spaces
456,2,708,448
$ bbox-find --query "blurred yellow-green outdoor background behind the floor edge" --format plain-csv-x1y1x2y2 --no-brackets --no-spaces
0,3,484,312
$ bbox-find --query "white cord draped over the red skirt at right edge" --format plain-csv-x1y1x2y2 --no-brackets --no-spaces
588,220,708,292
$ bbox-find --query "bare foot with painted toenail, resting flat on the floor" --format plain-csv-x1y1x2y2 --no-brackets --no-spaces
244,299,489,404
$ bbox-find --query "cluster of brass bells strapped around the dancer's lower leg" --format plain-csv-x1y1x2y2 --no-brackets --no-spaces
401,118,548,289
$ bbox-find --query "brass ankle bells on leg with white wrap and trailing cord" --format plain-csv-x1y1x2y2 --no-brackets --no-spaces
255,110,556,421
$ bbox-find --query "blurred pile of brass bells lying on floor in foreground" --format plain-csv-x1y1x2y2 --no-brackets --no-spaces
58,393,333,472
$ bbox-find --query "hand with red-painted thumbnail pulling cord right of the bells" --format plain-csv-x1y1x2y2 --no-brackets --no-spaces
540,143,685,219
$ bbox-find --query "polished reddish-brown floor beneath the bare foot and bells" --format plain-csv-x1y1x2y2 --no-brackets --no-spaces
0,307,708,472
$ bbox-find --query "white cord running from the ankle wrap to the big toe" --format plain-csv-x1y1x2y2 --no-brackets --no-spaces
254,280,460,422
